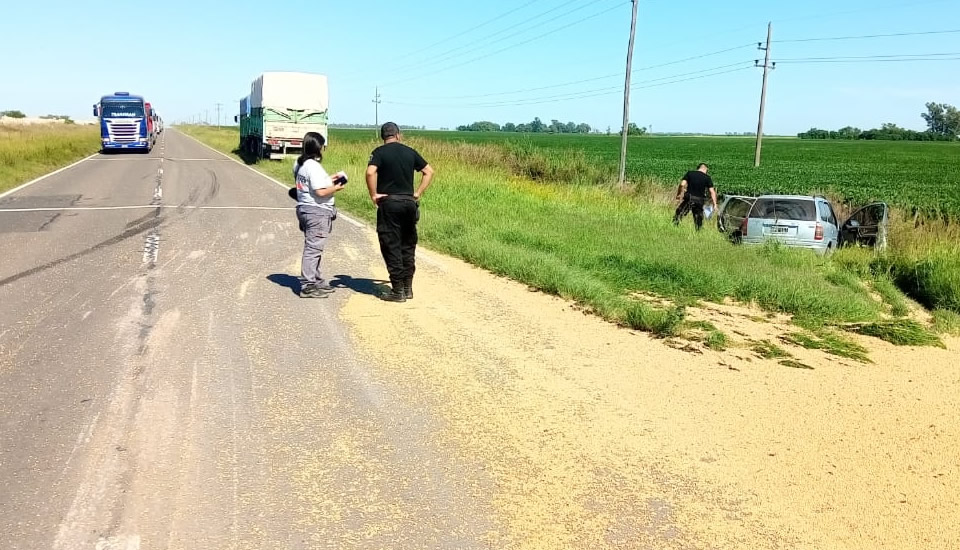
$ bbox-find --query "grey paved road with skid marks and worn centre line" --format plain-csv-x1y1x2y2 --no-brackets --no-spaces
0,131,491,550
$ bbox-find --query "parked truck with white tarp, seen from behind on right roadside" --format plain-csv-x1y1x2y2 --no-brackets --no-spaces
234,72,330,159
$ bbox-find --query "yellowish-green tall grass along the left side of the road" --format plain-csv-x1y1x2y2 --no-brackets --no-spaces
0,124,100,193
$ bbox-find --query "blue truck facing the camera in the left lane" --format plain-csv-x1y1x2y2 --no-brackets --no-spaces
93,92,153,153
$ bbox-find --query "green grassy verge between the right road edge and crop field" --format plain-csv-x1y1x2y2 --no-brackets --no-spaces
182,127,952,347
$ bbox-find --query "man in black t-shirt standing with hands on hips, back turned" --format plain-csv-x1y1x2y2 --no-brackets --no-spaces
367,122,433,302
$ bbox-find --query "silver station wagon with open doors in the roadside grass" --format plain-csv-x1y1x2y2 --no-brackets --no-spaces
717,195,889,254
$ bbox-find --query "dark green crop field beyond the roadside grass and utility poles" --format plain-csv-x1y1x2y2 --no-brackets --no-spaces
374,131,960,217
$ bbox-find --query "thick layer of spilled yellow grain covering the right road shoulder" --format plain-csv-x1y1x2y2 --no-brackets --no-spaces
342,236,960,549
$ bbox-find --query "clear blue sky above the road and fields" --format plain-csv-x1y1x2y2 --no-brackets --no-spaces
0,0,960,134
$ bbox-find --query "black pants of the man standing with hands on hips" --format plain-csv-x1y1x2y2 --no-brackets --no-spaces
377,195,420,288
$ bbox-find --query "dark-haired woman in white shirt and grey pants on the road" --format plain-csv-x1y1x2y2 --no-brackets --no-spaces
293,132,344,298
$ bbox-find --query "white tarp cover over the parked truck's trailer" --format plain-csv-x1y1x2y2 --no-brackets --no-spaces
250,72,330,111
